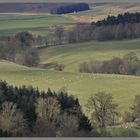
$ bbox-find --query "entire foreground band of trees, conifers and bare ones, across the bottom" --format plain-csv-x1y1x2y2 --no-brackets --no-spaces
0,81,140,137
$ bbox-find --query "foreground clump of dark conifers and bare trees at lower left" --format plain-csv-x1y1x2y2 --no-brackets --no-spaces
0,81,94,137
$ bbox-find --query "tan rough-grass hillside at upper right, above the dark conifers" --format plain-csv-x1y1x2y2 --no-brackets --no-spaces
71,3,140,22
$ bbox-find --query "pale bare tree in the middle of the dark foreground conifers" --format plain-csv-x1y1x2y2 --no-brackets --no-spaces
33,97,61,137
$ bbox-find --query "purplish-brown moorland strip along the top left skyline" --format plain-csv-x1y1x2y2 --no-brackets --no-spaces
0,3,88,13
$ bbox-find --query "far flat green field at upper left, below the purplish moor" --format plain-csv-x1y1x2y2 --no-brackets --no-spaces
0,15,75,36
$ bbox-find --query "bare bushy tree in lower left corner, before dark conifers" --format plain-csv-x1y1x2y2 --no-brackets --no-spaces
0,102,26,134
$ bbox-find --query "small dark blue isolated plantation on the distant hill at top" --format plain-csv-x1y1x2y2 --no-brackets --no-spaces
51,3,90,14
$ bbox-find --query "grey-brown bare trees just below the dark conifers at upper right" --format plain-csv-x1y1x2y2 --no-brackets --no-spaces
67,23,140,43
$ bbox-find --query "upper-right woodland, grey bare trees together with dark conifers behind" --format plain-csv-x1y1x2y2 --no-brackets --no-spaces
67,13,140,43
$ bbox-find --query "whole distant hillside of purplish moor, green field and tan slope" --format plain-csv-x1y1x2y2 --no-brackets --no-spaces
0,3,140,37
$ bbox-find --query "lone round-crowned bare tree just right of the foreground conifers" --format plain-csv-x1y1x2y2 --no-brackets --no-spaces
88,92,118,136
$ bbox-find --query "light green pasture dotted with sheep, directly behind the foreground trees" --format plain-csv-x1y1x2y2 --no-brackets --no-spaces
0,61,140,112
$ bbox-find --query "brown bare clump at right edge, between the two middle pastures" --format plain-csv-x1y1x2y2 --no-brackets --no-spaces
79,52,140,76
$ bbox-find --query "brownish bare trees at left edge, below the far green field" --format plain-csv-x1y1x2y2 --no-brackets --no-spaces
0,26,65,69
